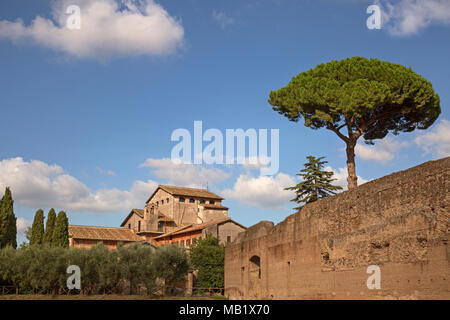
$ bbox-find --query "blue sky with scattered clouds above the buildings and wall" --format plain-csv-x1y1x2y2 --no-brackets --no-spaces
0,0,450,244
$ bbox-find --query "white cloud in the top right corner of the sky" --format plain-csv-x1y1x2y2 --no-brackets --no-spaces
375,0,450,36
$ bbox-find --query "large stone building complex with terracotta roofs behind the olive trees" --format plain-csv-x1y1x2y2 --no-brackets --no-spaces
69,185,246,248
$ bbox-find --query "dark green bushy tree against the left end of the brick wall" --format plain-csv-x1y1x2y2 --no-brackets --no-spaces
189,236,225,288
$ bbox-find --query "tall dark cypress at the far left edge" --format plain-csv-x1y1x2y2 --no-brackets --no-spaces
0,187,17,248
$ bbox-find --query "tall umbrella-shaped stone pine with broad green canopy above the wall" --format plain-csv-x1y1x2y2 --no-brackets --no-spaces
269,57,441,189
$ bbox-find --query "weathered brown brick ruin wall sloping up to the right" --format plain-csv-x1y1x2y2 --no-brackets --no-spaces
225,157,450,299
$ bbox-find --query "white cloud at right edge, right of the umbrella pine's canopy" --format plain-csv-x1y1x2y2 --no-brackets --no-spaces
415,119,450,158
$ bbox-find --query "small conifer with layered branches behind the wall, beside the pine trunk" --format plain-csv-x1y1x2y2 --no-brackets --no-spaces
285,156,342,210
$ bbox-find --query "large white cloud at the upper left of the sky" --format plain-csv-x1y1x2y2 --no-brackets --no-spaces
0,0,184,60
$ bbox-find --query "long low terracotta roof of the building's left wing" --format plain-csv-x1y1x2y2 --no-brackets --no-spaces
69,225,142,242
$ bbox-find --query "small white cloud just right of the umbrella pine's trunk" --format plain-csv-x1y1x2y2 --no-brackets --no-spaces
355,137,409,164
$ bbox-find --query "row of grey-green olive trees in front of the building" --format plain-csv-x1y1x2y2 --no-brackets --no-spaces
0,244,157,294
